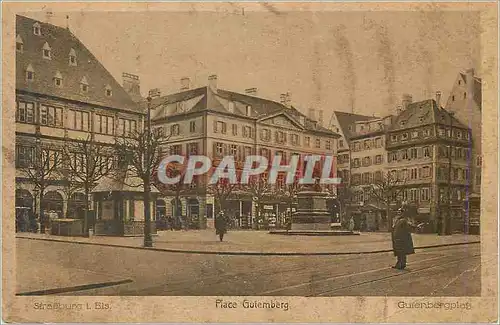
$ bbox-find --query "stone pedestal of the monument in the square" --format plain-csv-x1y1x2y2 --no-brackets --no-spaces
291,190,331,230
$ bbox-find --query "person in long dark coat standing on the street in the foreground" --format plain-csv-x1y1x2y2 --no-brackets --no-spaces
392,209,415,270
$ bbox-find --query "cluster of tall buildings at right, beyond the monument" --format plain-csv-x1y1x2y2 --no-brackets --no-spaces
330,74,482,232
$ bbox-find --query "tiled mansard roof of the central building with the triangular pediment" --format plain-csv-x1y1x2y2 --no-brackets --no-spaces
151,87,336,135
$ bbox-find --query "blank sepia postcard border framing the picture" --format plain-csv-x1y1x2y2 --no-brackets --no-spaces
2,2,498,323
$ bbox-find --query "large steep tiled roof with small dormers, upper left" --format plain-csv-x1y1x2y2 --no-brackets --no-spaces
16,16,139,111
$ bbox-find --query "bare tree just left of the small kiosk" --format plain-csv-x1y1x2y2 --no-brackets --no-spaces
62,135,112,235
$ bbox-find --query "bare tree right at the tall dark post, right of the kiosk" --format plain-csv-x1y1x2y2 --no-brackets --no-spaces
115,127,168,247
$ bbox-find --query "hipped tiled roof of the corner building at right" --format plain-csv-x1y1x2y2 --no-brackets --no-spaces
390,99,467,131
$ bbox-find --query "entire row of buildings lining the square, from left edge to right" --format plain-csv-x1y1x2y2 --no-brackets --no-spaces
15,16,481,230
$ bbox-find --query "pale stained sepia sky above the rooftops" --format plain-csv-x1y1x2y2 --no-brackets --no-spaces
25,7,480,119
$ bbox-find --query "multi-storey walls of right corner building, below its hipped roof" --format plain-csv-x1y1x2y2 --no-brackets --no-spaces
387,124,470,230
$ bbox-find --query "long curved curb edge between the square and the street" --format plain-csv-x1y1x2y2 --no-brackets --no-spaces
16,236,481,256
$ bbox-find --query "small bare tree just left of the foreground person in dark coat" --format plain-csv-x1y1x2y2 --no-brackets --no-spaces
367,171,406,231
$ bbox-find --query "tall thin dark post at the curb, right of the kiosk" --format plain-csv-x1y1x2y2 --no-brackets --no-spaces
144,95,153,247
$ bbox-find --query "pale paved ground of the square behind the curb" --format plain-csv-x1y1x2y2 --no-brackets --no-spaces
17,230,480,255
